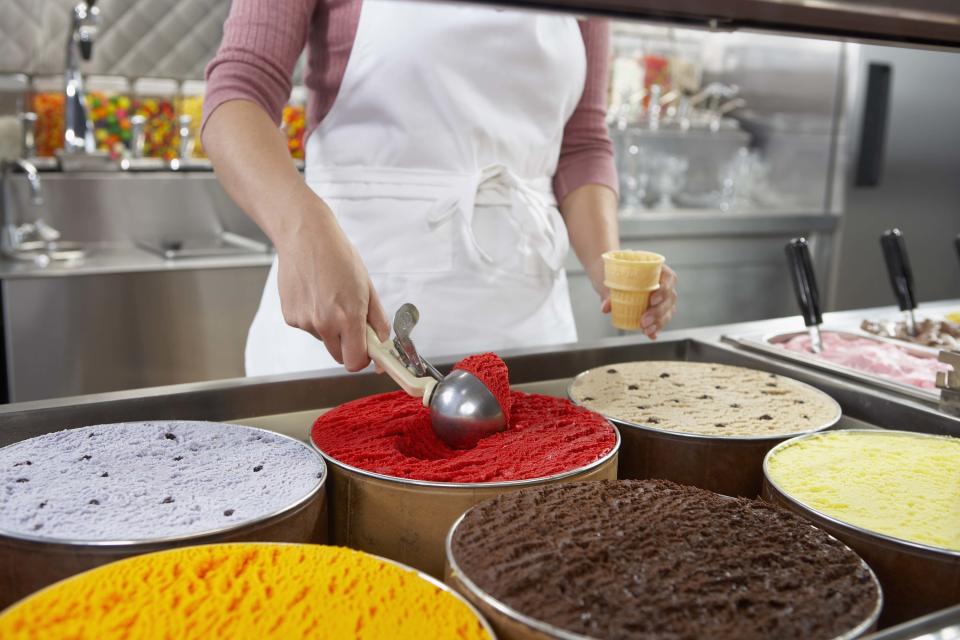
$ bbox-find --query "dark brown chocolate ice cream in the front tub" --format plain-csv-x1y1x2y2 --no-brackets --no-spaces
451,480,879,640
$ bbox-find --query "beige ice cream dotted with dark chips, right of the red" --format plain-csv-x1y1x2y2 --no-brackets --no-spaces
570,361,840,437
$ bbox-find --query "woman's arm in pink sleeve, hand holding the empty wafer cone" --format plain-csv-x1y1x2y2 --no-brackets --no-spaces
554,19,677,338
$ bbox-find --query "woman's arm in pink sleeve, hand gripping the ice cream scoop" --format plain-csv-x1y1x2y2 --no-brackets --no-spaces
202,0,388,371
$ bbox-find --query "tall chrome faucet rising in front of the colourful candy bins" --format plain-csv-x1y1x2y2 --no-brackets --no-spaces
63,0,100,153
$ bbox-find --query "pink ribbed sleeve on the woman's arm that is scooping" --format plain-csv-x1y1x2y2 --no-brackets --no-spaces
203,0,317,130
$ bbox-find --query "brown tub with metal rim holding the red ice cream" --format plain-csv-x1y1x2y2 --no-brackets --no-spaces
311,427,621,578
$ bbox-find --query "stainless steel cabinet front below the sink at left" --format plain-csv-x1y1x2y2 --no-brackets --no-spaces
2,267,266,402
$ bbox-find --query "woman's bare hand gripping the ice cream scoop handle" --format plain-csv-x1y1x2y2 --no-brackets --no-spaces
277,205,390,371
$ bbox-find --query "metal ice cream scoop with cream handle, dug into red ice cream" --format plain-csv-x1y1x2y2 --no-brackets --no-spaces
367,325,507,449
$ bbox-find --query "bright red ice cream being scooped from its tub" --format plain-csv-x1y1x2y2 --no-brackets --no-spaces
312,354,616,482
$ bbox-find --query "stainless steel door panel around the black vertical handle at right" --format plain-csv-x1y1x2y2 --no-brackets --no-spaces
830,46,960,311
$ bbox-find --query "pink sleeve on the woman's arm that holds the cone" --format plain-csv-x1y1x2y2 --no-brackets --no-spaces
553,18,619,202
